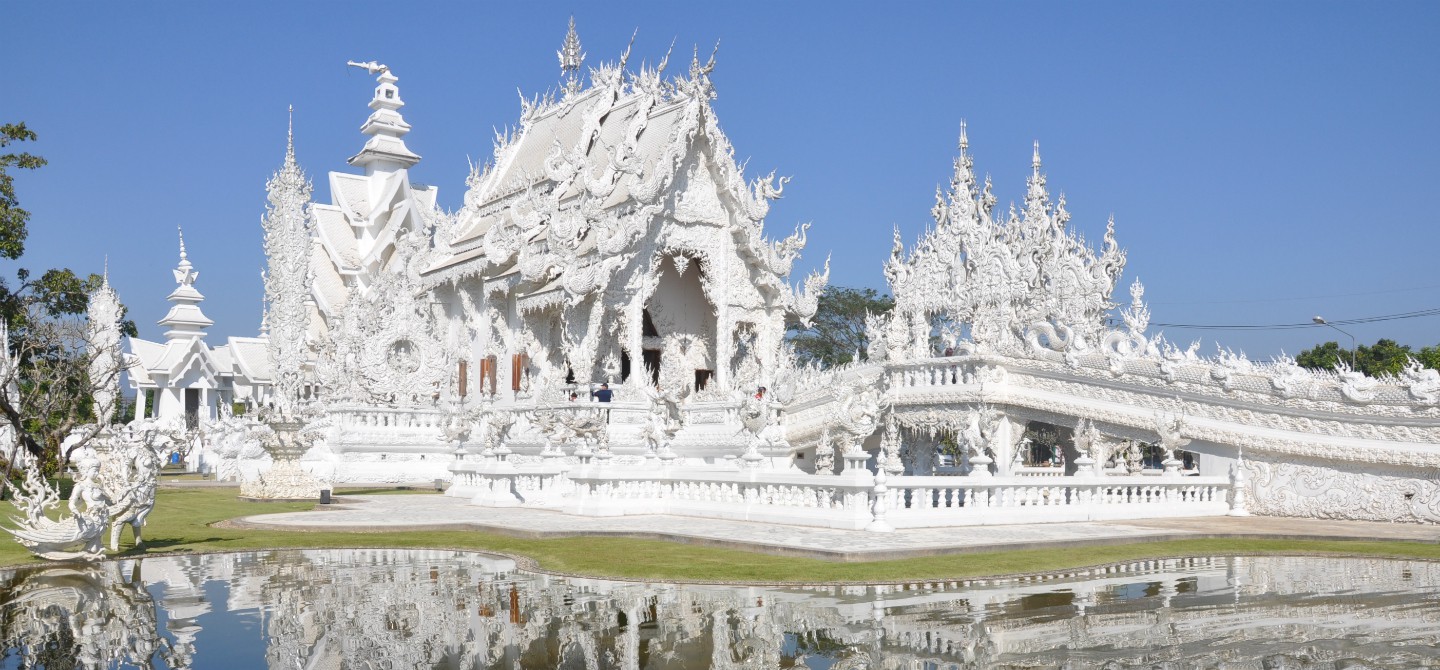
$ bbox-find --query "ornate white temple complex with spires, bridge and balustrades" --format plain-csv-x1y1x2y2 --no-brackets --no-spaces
132,24,1440,530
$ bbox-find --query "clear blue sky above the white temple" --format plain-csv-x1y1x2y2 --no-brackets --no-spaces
0,1,1440,359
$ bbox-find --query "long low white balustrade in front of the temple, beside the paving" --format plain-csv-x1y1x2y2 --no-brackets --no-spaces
489,467,1231,530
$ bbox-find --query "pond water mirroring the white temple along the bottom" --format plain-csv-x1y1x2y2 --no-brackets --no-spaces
0,550,1440,670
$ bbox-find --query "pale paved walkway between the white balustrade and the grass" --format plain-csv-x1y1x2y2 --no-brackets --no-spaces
229,496,1440,560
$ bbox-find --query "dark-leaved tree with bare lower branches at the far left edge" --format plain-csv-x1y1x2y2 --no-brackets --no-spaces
0,122,135,474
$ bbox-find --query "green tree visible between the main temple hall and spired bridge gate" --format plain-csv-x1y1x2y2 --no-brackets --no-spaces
786,287,896,366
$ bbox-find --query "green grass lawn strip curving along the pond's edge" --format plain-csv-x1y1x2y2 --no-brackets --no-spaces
0,488,1440,582
